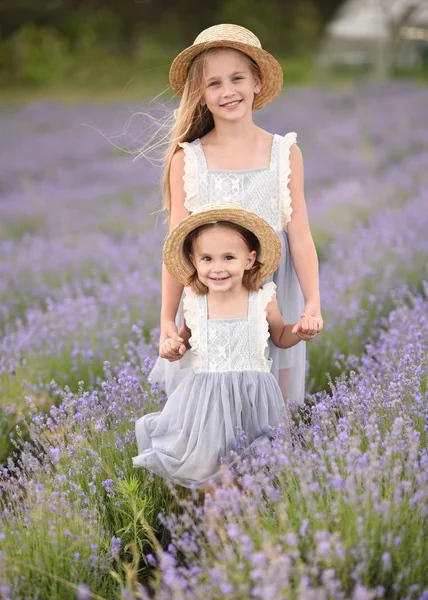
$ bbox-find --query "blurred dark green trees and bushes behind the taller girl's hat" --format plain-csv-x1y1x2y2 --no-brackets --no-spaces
0,0,344,87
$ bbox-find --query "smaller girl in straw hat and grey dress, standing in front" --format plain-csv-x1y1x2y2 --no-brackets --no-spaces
133,204,313,489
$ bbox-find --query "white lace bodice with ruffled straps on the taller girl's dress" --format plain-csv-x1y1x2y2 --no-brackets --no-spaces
180,133,296,231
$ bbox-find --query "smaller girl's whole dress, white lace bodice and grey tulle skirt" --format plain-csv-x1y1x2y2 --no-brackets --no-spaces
133,282,286,488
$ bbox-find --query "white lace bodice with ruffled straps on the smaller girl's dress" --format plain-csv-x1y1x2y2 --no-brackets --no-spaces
183,282,276,373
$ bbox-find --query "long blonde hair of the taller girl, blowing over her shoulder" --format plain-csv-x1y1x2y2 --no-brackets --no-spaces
162,47,262,221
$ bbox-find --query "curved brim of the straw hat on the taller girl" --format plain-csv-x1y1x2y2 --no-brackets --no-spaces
169,39,284,110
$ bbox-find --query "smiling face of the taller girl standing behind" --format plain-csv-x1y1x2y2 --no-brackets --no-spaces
201,48,261,121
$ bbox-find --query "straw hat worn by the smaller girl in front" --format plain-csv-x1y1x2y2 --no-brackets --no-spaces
163,202,282,285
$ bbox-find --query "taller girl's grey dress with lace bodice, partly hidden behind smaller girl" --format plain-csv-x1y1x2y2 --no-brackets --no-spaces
150,133,306,404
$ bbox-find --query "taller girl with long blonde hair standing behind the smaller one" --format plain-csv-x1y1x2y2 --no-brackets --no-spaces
151,25,323,404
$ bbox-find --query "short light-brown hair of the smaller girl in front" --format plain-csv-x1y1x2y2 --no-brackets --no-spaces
183,221,263,296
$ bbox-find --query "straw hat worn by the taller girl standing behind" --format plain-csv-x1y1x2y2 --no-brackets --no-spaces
169,25,283,110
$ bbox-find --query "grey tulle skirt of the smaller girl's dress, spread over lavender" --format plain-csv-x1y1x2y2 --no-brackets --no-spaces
132,371,286,488
